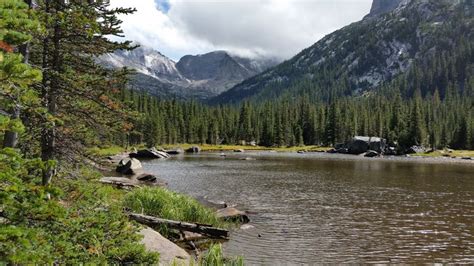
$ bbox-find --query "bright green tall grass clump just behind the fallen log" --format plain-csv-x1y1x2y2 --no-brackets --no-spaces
124,187,226,227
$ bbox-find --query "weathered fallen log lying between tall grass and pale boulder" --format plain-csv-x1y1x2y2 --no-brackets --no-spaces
128,213,229,239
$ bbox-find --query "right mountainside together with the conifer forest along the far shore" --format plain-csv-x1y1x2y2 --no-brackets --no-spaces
113,0,474,152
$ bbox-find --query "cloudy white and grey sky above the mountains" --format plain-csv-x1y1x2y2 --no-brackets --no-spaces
111,0,372,60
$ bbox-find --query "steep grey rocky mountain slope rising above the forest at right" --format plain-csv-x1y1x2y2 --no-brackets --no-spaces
211,0,474,103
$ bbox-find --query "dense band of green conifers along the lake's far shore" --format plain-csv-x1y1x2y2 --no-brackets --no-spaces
117,55,474,149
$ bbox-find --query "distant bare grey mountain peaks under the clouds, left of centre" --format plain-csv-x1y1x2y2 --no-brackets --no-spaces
99,46,277,99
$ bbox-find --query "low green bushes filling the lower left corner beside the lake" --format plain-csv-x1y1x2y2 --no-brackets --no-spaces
0,149,158,264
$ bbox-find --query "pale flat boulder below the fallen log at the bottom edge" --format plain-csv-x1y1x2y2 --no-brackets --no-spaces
139,227,191,265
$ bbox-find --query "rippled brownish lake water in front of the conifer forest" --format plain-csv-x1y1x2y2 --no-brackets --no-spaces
144,152,474,265
